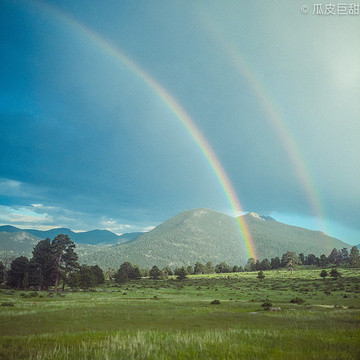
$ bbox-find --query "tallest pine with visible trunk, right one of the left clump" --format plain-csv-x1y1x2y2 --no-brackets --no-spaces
51,234,79,292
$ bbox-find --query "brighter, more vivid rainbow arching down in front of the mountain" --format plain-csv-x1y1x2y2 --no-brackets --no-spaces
22,0,257,259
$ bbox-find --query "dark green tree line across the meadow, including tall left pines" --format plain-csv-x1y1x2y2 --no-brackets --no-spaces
0,234,360,292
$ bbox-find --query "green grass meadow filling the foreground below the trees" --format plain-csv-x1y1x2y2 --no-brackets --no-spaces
0,269,360,360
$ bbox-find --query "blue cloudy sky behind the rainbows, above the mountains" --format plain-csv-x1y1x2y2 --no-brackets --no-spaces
0,0,360,244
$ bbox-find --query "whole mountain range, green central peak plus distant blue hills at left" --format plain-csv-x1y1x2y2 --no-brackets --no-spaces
0,209,351,269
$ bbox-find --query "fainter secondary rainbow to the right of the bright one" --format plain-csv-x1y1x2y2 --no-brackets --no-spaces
203,13,326,229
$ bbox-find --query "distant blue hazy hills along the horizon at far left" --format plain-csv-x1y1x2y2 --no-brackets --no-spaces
0,225,143,245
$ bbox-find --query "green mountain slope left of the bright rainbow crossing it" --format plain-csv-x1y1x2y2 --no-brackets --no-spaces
81,209,246,268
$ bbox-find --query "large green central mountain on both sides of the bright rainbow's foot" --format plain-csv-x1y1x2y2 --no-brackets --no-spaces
80,209,350,269
